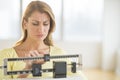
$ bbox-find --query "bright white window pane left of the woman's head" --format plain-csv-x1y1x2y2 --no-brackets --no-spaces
0,0,20,39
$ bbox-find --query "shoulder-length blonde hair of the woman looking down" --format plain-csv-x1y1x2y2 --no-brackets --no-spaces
16,1,55,46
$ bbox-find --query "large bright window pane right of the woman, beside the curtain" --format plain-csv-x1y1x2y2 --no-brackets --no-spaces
63,0,103,41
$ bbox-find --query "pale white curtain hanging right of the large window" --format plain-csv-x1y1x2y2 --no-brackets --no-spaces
102,0,120,70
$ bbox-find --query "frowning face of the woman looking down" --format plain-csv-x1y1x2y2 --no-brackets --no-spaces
24,11,50,41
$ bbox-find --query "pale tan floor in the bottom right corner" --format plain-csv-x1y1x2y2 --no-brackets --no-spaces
83,69,120,80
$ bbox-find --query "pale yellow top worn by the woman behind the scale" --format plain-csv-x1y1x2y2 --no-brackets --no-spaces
0,46,86,80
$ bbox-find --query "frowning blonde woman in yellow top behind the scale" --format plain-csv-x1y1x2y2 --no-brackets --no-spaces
0,1,87,79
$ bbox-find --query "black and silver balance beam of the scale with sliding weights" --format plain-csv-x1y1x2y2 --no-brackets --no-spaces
0,54,82,78
